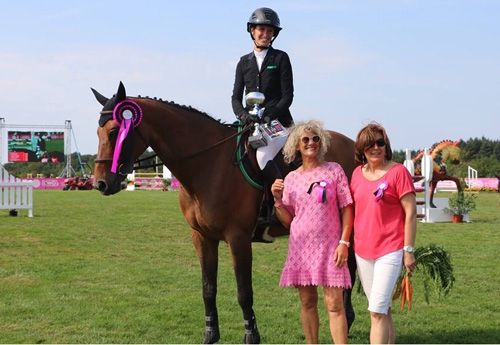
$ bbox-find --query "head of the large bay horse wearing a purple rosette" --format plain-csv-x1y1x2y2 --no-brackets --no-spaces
91,82,144,195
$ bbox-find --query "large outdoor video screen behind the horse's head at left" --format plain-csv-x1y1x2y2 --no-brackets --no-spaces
7,131,64,163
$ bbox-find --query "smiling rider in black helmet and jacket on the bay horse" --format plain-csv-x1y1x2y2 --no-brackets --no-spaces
231,7,293,204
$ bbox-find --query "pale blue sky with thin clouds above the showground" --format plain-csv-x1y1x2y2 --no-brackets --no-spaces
0,0,500,154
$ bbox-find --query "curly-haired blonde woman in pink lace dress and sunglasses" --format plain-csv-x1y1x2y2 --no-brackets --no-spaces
271,120,353,344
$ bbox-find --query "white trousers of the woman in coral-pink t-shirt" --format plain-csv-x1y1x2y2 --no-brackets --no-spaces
356,249,403,314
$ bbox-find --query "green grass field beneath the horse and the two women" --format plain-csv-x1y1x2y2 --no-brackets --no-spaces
0,190,500,344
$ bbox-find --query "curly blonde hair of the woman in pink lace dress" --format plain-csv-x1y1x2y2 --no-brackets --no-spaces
283,120,330,164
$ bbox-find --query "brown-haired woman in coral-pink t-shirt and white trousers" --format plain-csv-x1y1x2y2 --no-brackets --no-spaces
351,122,417,344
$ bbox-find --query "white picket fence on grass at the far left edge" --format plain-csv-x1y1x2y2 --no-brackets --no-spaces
0,165,33,217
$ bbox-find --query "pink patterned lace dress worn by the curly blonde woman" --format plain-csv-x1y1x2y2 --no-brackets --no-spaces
279,162,352,288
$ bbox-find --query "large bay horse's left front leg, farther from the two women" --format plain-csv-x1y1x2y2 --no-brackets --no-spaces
191,229,220,344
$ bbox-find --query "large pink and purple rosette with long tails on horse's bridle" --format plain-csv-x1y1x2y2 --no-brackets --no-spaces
111,99,142,174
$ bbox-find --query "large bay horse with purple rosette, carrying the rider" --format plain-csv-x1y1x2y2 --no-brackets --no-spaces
92,82,355,344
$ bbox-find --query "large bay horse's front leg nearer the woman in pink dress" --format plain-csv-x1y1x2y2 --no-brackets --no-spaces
228,234,260,344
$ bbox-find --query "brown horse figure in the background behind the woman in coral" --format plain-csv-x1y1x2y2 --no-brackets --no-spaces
412,140,462,208
